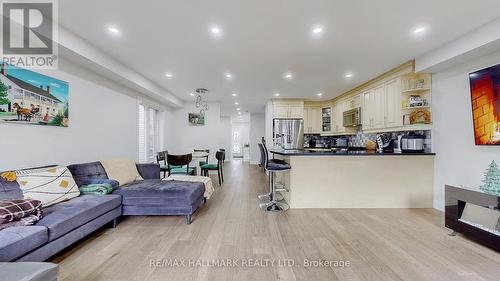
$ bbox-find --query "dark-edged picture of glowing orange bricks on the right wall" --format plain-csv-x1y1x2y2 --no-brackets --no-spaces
469,64,500,145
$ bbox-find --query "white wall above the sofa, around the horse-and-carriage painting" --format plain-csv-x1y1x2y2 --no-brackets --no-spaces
0,59,143,171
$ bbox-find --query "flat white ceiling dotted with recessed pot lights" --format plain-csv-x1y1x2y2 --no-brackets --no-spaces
59,0,500,115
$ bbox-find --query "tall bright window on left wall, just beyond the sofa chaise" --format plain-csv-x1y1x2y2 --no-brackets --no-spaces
137,101,160,163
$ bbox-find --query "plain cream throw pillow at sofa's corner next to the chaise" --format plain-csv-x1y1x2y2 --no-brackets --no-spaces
101,159,143,186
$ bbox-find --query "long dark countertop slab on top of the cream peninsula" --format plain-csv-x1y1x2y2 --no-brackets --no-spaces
269,149,436,156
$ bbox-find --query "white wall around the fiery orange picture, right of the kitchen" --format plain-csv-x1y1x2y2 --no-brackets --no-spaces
432,49,500,210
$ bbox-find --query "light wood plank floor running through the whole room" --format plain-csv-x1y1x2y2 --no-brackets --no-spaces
54,161,500,281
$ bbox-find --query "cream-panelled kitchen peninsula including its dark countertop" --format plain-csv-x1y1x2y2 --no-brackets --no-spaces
270,150,434,208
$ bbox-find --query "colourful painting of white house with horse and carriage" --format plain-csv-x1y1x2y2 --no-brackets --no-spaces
0,63,69,127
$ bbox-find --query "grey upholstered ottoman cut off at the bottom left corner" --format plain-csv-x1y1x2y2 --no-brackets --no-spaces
0,262,59,281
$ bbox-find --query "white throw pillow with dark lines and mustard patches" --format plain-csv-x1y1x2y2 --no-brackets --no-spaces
16,166,80,207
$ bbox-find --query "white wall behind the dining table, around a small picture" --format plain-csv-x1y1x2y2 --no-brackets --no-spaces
164,101,231,162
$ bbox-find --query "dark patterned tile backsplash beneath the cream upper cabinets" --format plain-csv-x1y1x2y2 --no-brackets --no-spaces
304,130,432,152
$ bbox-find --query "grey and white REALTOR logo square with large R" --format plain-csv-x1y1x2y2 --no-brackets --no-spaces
1,0,58,69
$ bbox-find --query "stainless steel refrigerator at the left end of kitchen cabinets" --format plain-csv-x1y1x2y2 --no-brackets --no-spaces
273,119,304,149
